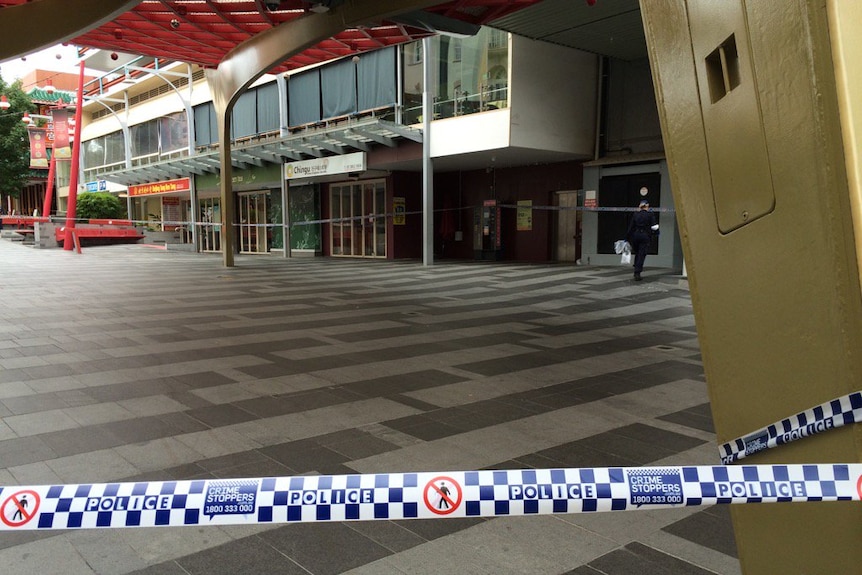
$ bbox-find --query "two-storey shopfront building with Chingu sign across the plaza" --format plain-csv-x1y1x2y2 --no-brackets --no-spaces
72,28,682,268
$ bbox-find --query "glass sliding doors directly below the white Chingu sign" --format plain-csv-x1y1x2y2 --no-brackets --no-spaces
329,180,386,258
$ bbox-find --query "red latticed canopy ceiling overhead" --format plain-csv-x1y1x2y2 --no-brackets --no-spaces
0,0,539,72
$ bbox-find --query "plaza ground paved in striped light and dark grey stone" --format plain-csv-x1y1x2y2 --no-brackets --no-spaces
0,239,740,575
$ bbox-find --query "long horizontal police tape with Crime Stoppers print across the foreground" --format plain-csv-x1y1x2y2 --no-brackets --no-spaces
0,464,862,531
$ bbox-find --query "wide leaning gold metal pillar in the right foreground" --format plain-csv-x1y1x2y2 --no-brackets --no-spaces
641,0,862,575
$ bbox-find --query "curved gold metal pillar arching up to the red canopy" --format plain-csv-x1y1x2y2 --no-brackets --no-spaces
207,0,439,267
